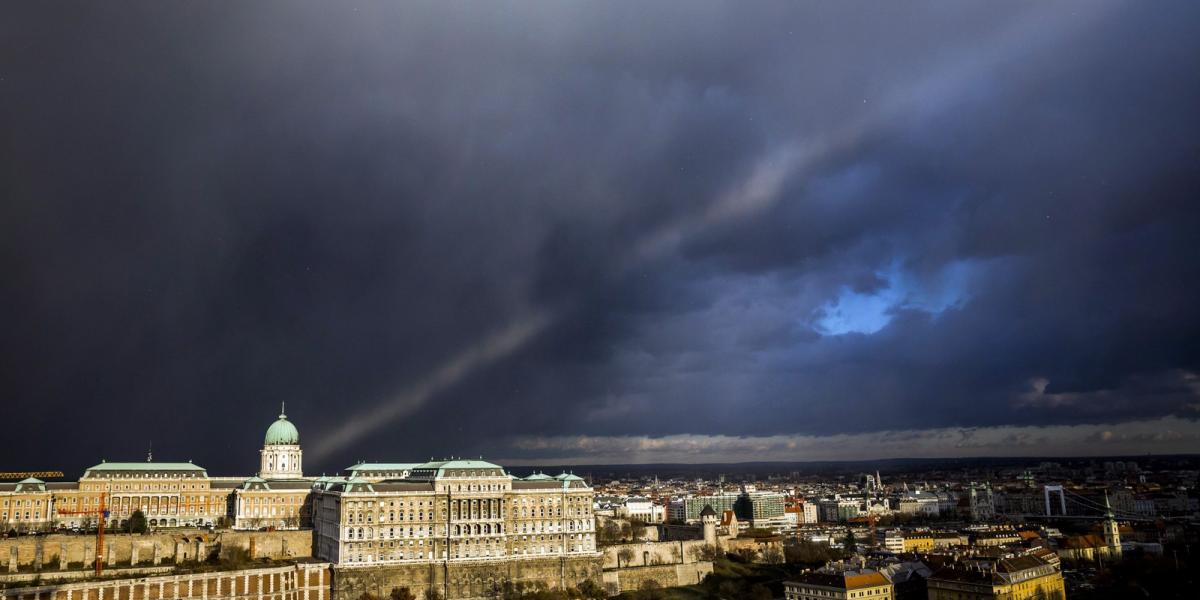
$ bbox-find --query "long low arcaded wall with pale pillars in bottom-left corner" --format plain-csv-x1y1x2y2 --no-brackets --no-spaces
0,563,330,600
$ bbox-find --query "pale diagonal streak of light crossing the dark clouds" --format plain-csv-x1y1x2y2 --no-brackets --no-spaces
310,1,1118,461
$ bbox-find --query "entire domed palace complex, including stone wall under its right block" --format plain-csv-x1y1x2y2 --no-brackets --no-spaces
0,412,602,600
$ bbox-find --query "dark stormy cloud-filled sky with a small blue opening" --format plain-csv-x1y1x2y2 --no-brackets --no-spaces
0,0,1200,474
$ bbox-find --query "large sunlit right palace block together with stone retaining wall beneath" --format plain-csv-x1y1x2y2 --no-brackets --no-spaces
312,460,600,598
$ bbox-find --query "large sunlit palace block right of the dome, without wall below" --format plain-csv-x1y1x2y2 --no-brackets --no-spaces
313,460,595,564
